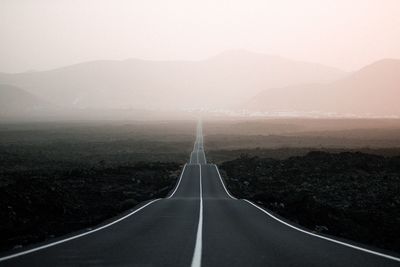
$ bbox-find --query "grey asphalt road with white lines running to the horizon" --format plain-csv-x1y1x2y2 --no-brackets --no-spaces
0,124,400,267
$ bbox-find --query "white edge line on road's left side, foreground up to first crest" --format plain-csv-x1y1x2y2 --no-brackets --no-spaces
0,198,160,262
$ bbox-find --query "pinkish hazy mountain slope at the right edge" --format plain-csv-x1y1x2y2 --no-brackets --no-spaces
244,59,400,116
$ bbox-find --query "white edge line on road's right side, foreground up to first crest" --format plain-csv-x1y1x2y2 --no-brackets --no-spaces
243,199,400,262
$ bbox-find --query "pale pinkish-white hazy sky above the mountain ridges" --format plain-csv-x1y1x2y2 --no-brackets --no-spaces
0,0,400,72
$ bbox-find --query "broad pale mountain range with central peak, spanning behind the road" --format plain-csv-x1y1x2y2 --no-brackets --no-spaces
0,50,346,110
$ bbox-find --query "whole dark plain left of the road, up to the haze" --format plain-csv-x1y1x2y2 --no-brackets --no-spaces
0,122,193,254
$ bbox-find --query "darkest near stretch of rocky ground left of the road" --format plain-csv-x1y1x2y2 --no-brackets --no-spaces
0,162,181,253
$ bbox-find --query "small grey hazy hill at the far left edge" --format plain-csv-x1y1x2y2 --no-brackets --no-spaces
0,84,52,117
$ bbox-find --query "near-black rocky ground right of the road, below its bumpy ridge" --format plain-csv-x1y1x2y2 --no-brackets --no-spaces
220,151,400,252
